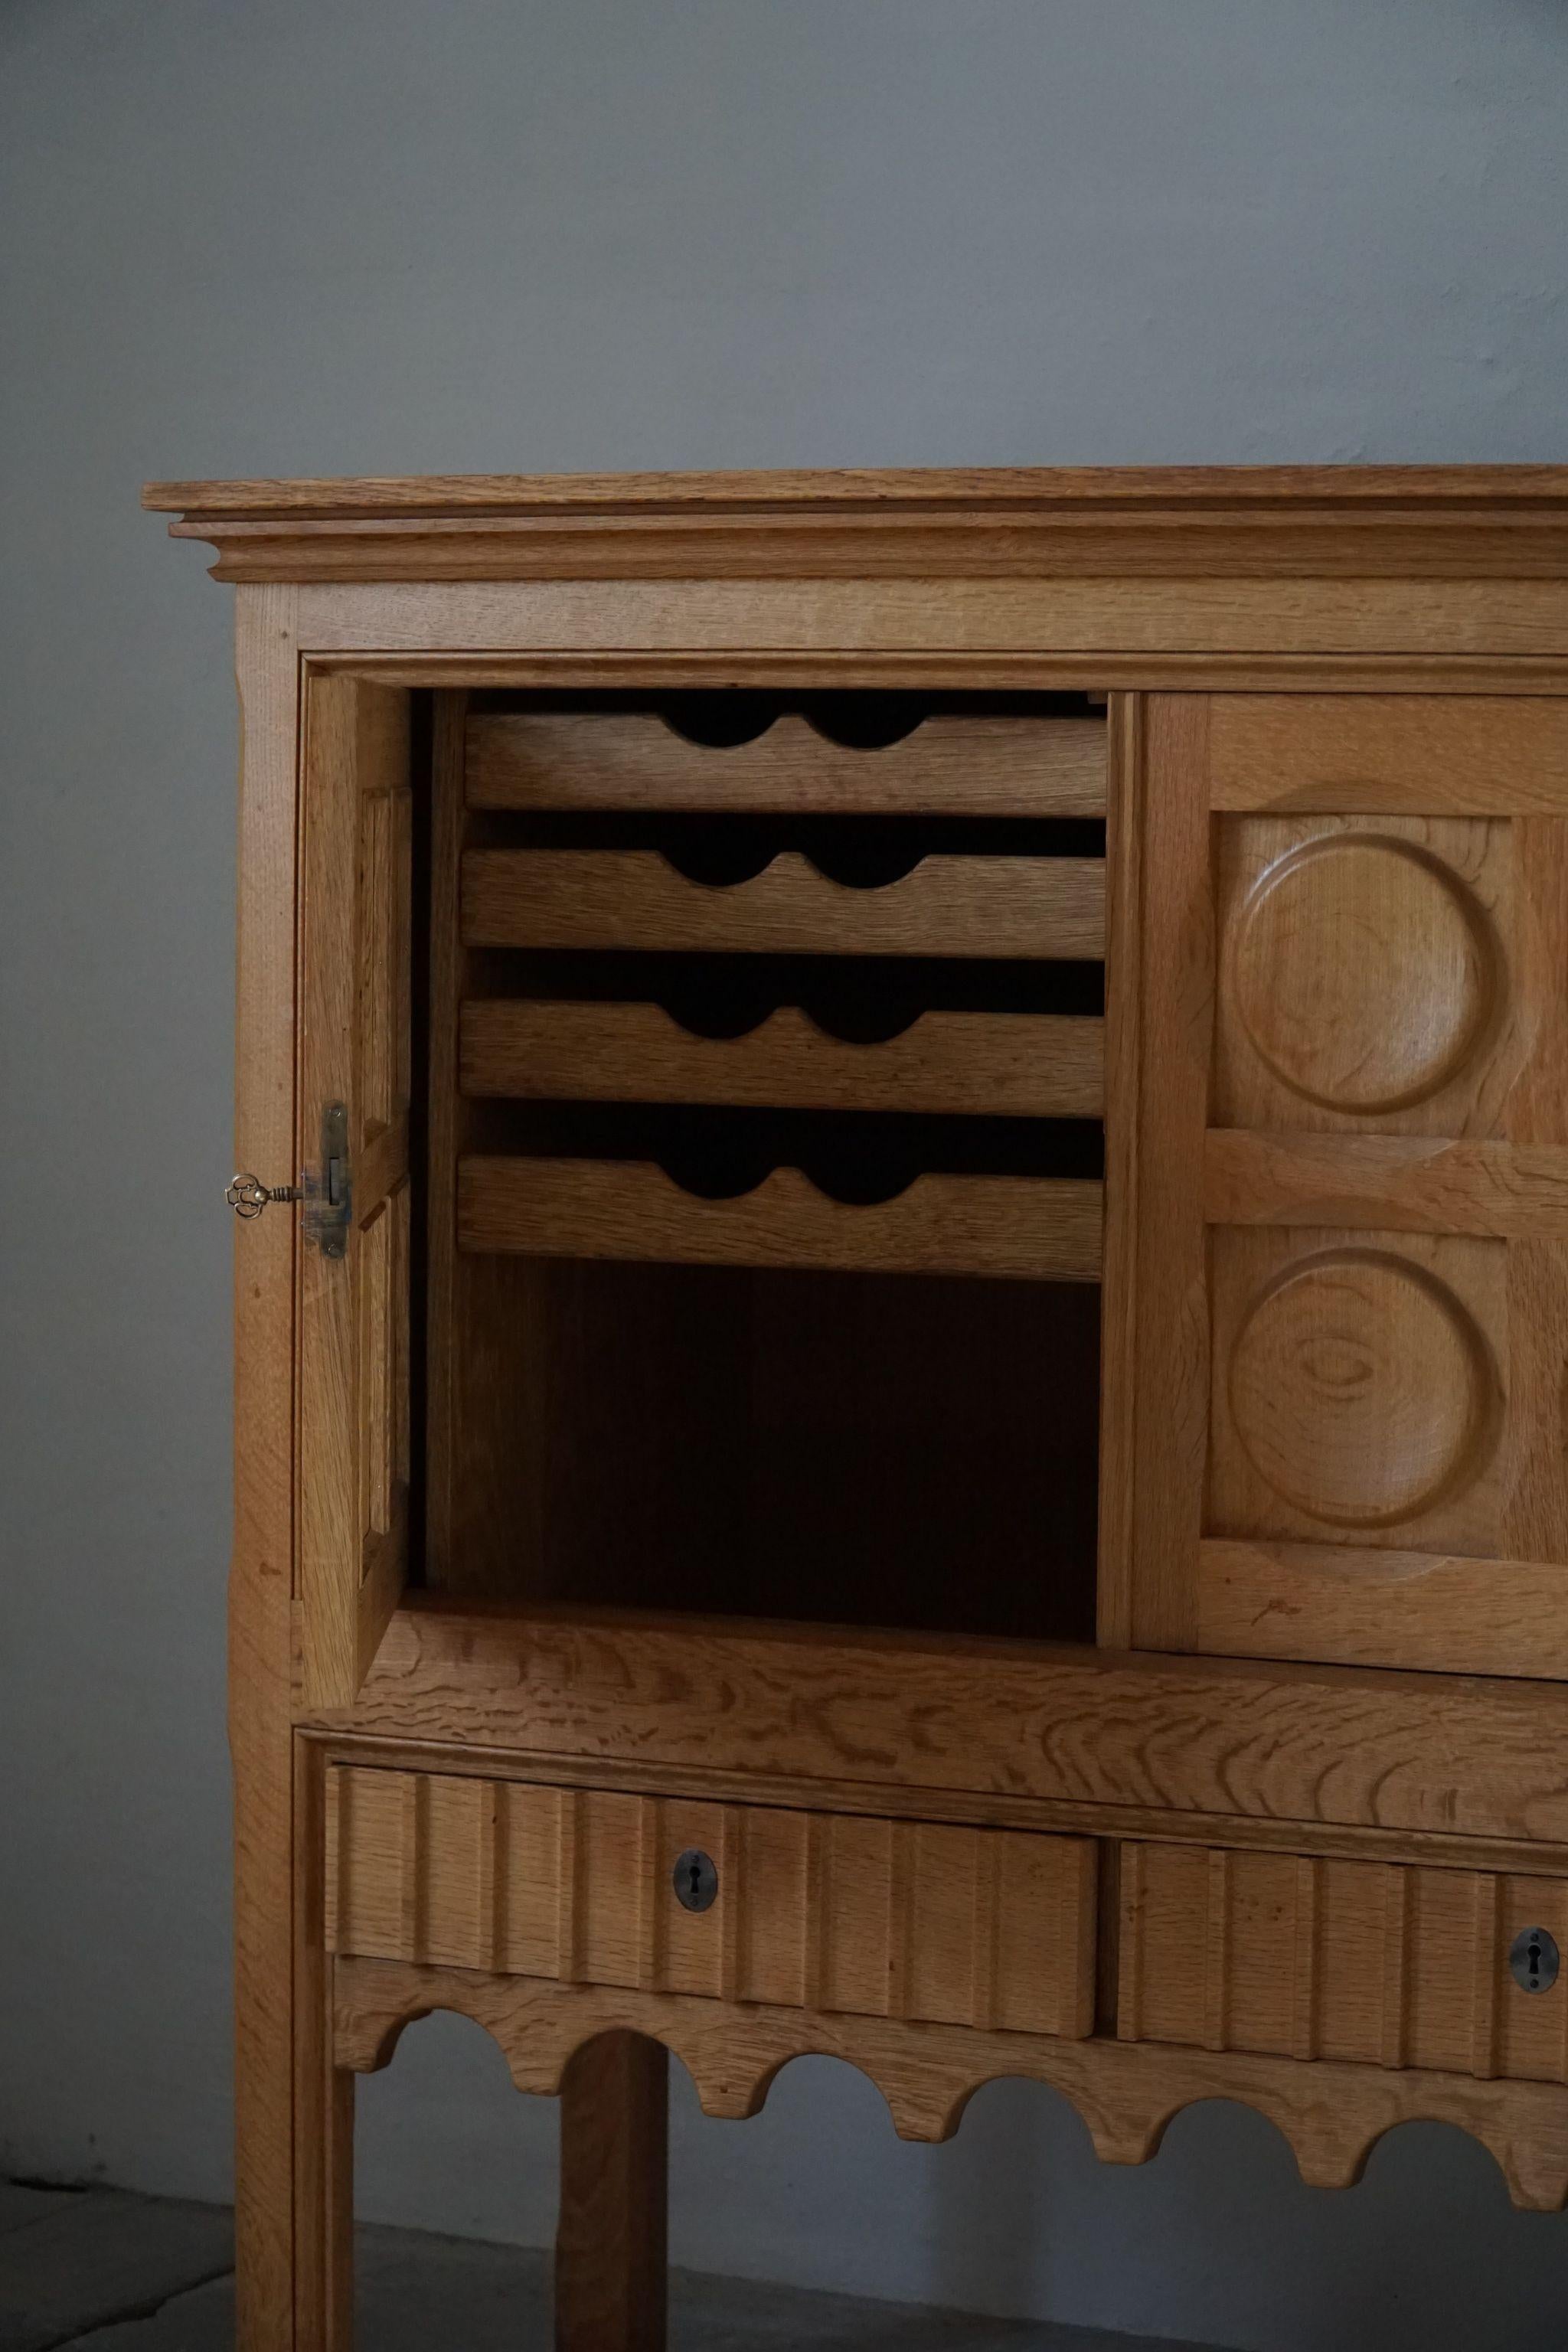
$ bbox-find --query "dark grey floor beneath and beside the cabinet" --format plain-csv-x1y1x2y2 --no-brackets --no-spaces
0,2180,1199,2352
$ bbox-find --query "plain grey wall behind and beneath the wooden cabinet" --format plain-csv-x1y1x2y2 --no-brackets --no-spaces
0,0,1568,2352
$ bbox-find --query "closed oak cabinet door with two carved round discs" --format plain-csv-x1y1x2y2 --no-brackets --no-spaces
1107,694,1568,1677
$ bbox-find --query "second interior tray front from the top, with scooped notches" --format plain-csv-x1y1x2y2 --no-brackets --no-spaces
463,849,1105,959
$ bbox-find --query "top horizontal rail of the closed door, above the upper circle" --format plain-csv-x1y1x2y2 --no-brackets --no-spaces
1210,694,1568,818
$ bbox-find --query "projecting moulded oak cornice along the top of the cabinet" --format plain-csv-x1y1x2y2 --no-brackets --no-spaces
143,466,1568,588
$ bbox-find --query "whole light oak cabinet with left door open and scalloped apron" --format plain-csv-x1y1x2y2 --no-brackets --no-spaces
148,468,1568,2352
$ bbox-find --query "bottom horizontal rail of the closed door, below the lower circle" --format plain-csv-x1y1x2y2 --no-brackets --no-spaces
1199,1536,1568,1681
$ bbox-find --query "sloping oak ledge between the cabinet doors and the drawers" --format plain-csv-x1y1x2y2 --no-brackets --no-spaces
315,1599,1568,1844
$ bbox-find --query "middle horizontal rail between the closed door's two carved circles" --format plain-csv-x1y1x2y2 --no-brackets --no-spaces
1204,1126,1568,1242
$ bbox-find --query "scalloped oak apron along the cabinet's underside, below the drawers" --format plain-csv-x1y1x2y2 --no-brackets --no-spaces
336,1959,1568,2213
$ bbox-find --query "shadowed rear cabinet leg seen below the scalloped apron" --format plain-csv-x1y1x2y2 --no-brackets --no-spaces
555,2032,670,2352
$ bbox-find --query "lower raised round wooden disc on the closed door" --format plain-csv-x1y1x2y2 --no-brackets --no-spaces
1230,1249,1498,1527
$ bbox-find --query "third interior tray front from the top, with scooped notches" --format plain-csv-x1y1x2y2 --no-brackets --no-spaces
461,998,1105,1119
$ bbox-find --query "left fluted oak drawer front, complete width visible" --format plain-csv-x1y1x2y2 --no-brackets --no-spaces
327,1764,1096,2039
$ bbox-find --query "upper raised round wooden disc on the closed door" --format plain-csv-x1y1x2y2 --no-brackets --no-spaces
1232,832,1498,1112
